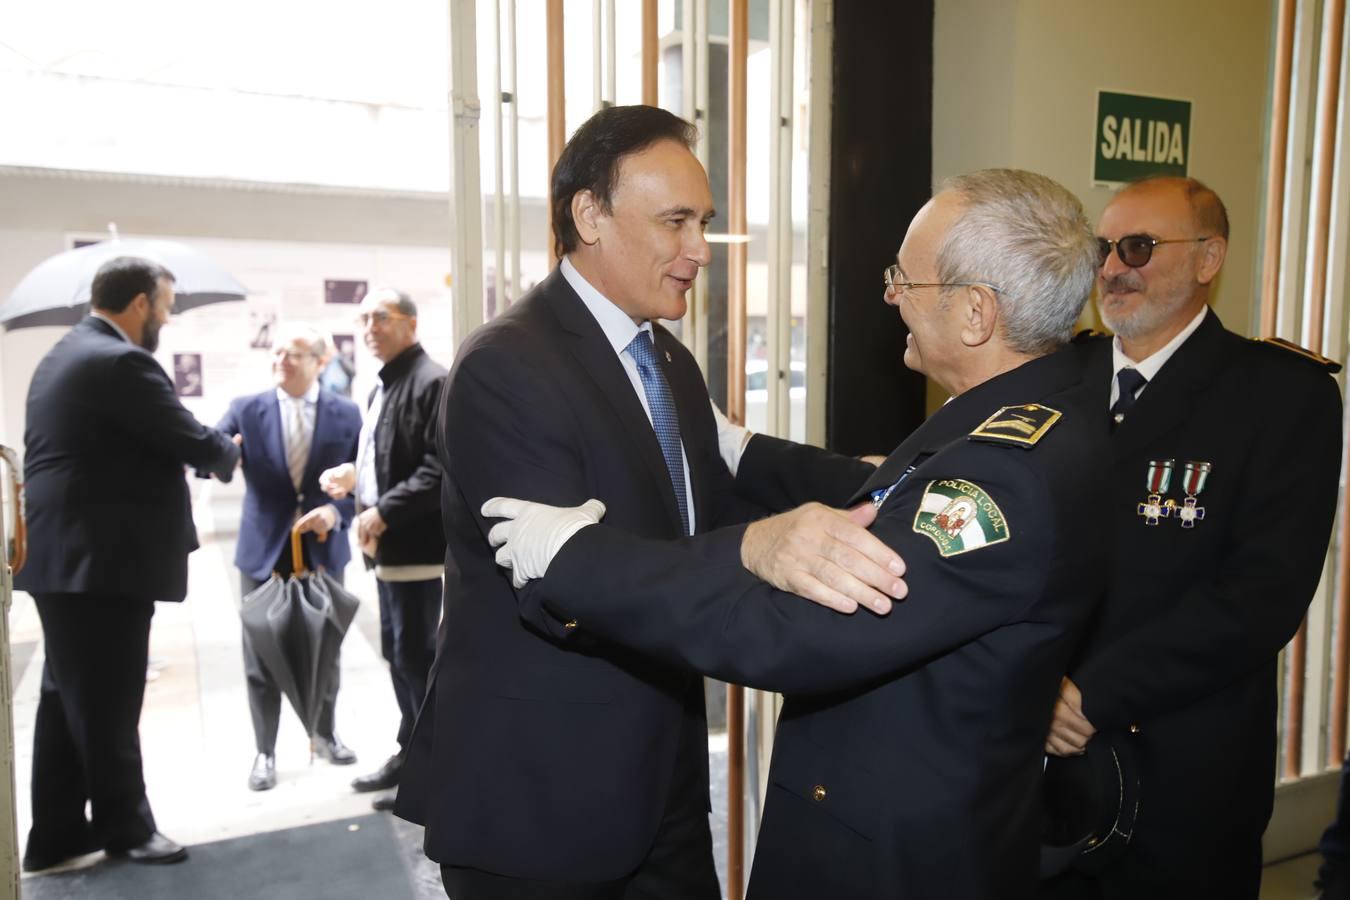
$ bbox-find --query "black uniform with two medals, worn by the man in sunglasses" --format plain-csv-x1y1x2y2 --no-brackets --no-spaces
1069,310,1341,899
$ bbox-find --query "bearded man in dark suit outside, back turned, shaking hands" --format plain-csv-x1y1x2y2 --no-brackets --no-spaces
15,256,239,870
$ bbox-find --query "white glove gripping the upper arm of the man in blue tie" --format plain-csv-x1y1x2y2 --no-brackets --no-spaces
482,497,605,588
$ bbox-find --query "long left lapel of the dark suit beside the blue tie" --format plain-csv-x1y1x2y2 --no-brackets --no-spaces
544,269,683,533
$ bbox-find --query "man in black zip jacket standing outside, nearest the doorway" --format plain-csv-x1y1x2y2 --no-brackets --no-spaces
320,287,446,810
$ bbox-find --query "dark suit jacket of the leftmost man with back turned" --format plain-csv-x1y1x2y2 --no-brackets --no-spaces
15,316,239,600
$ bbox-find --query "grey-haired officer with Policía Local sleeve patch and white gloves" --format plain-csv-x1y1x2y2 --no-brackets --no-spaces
483,170,1107,900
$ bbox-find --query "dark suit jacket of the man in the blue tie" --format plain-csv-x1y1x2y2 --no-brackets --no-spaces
397,270,761,881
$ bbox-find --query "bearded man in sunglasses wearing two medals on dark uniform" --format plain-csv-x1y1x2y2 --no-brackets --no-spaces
1046,178,1341,900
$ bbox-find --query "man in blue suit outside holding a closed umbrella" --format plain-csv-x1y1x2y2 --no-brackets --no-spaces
216,325,360,791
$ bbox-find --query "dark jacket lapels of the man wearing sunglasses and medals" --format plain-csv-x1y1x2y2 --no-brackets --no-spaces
1098,310,1226,457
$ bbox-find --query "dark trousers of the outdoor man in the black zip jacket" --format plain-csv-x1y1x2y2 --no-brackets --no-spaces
375,578,440,750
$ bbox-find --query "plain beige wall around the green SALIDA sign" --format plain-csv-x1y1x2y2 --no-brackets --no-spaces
933,0,1274,333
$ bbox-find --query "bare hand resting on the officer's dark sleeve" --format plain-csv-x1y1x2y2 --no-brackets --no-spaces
741,503,909,615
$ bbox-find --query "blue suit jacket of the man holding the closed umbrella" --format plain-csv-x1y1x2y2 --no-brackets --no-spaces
216,389,360,582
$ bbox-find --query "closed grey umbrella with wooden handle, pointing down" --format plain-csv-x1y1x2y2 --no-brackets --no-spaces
239,532,360,737
